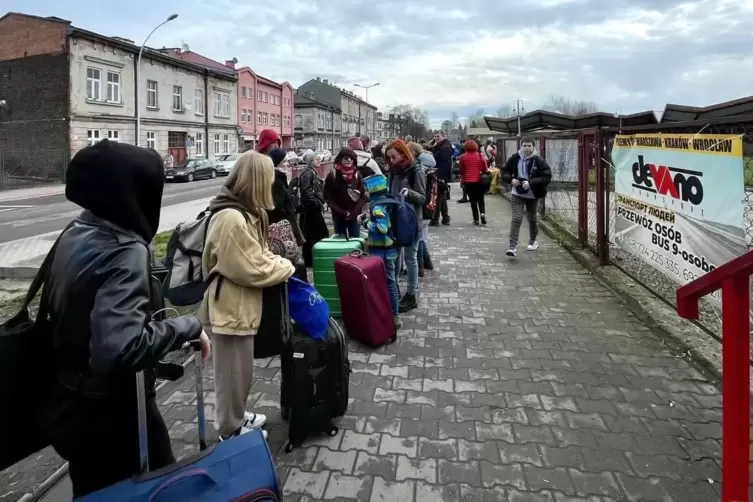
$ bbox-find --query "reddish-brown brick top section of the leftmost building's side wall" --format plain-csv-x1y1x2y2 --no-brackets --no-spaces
0,14,70,61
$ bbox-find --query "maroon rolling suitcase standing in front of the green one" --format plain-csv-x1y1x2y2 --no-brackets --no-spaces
335,251,397,347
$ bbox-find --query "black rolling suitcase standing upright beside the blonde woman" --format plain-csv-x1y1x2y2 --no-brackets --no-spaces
280,285,350,452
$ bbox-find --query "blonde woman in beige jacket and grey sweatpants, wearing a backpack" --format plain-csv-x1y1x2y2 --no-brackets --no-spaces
200,151,295,440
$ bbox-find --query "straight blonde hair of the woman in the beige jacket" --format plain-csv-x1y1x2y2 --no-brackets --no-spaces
225,150,275,242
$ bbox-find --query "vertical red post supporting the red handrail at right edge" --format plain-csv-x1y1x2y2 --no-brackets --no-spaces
722,274,750,502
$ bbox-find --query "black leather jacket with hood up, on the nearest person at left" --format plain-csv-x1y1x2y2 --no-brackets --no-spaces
51,141,201,396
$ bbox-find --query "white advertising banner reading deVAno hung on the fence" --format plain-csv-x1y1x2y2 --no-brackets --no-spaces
612,134,747,301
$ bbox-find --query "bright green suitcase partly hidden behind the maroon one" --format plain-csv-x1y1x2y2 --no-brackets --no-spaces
312,237,366,317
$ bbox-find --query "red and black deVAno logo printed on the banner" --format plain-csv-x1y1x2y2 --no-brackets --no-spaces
633,155,703,206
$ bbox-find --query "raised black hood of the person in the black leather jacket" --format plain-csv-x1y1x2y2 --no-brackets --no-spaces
65,140,165,242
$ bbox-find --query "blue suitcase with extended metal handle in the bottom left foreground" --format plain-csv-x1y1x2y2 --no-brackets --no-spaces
75,346,282,502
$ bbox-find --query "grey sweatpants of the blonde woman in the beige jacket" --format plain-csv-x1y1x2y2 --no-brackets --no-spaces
212,335,254,435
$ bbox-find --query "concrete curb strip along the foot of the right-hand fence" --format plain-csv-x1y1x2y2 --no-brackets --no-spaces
539,220,722,381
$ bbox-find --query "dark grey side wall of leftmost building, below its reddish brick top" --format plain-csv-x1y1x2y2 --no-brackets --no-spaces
0,54,70,189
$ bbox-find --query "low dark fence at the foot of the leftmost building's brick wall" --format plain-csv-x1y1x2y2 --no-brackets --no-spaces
0,150,68,190
